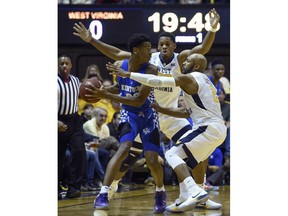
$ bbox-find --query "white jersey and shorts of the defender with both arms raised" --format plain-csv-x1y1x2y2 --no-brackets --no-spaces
150,52,190,142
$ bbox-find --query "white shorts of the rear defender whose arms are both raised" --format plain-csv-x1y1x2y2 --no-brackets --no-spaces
159,114,192,143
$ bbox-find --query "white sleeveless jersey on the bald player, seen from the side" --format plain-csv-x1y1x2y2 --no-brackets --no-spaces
183,72,223,126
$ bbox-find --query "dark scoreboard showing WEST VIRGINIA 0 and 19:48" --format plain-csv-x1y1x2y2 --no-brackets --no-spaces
58,5,230,44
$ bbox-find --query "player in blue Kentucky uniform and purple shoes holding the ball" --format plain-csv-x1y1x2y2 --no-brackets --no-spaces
86,34,166,213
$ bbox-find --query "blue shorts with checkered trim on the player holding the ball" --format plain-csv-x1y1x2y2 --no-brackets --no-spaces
119,109,160,152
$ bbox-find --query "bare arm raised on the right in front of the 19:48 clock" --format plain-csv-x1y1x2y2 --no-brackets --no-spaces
178,8,220,65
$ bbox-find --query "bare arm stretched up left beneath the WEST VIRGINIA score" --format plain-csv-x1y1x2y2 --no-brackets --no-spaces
73,22,131,60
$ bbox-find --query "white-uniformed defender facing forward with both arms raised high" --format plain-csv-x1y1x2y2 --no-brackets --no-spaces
73,8,222,209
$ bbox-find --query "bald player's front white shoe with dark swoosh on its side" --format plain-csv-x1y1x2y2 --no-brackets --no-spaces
179,187,209,211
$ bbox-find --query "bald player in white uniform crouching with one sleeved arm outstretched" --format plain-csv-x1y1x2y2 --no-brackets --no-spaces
106,53,227,213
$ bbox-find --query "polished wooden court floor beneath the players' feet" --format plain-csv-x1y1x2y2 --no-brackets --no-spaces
58,184,230,216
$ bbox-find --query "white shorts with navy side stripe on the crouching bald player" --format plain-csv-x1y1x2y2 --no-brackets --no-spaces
169,121,227,167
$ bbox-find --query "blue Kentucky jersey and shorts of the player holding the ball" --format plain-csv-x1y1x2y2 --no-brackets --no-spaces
117,59,160,152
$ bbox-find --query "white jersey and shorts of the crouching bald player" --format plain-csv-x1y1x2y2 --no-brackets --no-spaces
166,72,227,168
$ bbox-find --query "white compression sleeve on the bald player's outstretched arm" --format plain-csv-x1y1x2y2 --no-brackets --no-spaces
130,72,176,87
